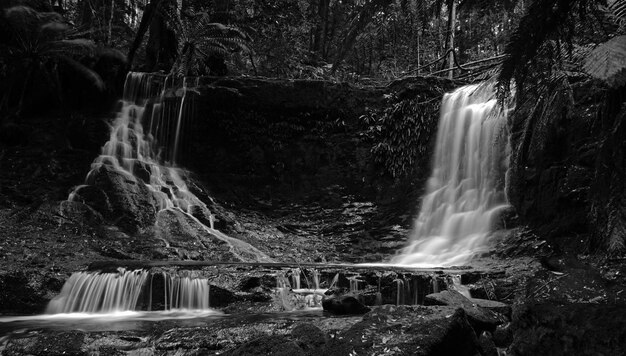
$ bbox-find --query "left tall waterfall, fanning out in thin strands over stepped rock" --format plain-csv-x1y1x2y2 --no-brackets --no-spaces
68,72,271,261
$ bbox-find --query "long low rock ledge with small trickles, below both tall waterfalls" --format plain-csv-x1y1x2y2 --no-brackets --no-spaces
80,260,505,311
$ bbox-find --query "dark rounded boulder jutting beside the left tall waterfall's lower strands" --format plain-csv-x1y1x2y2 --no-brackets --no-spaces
87,165,158,232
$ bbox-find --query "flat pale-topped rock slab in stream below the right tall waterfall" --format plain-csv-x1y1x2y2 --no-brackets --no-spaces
424,290,506,332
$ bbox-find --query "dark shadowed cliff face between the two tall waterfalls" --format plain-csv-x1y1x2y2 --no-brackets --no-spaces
181,78,453,206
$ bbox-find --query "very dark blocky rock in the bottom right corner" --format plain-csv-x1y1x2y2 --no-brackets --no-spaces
510,303,626,356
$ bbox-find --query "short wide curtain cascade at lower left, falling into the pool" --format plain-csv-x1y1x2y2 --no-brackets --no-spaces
47,268,209,314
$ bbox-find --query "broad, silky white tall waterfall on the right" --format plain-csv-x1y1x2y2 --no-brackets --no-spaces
391,85,508,267
